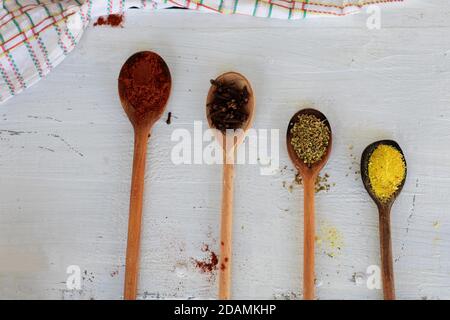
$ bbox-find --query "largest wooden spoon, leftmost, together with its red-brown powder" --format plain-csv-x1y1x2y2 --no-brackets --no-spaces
118,51,172,300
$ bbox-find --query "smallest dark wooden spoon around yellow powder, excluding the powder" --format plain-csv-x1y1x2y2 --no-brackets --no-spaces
361,140,406,300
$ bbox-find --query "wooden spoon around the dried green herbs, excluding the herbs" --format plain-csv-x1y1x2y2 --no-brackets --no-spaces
286,109,332,300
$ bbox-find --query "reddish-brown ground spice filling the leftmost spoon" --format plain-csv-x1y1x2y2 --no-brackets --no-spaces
119,52,171,115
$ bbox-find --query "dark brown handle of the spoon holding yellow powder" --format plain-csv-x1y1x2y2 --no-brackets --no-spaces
379,207,395,300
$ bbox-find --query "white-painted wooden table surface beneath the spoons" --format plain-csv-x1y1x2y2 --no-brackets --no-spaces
0,0,450,299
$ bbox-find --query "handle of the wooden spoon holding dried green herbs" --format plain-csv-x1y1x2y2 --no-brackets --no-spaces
303,177,315,300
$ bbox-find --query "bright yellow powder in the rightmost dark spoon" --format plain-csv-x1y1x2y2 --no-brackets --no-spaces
368,144,406,202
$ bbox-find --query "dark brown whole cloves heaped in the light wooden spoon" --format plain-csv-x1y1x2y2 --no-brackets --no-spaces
206,80,249,133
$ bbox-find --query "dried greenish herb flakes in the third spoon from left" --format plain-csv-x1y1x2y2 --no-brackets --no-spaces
290,114,330,166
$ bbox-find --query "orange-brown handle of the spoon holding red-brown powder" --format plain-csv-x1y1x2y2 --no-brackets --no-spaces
124,128,149,300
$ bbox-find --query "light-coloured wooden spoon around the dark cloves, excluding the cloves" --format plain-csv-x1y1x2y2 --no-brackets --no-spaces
206,72,255,300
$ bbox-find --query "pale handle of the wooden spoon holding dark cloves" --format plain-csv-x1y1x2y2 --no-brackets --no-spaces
219,159,234,300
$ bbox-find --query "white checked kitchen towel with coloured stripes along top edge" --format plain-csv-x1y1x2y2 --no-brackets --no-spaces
0,0,403,103
